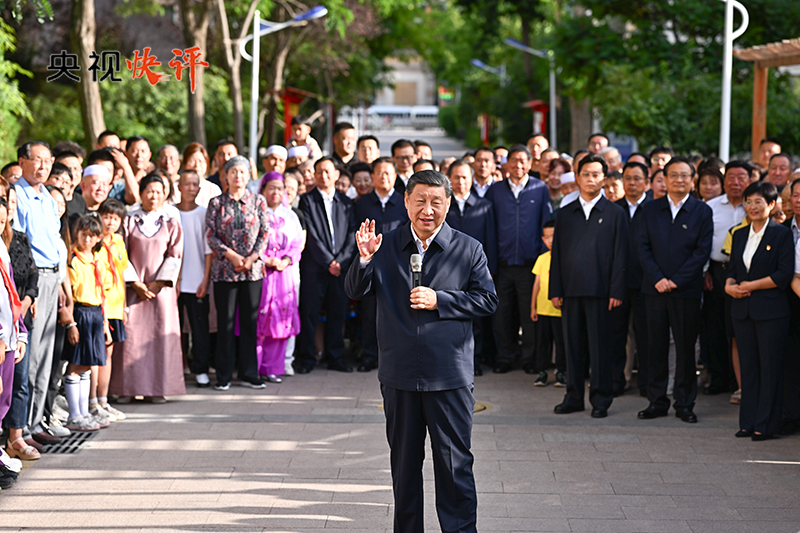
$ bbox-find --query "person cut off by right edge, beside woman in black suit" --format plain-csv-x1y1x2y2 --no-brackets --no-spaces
781,179,800,435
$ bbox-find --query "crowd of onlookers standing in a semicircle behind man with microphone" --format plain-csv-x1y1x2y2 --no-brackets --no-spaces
0,116,800,488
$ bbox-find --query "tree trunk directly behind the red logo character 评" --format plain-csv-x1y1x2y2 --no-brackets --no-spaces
179,0,213,146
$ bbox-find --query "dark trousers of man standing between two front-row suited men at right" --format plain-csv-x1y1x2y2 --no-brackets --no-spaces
611,289,648,394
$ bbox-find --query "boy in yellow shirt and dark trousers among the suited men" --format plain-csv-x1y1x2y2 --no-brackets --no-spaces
531,220,567,387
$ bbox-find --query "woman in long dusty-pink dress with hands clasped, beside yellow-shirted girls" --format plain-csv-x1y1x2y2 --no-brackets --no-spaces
110,171,186,403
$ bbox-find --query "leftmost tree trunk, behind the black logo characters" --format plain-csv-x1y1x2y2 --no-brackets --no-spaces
70,0,106,150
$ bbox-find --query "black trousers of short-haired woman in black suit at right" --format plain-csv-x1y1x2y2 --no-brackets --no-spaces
733,317,797,435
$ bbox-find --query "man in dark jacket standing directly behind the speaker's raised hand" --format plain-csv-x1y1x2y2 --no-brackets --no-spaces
355,157,408,372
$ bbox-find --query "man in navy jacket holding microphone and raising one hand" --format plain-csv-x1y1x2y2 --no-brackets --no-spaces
346,170,497,533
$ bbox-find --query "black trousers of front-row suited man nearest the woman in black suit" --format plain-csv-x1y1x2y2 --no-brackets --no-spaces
645,295,700,410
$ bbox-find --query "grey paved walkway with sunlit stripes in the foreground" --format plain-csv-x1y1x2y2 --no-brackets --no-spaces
0,368,800,533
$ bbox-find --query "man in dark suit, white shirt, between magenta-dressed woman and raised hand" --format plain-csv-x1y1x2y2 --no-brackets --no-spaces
294,157,357,374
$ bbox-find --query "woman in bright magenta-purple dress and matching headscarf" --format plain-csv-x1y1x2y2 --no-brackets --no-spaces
256,172,303,383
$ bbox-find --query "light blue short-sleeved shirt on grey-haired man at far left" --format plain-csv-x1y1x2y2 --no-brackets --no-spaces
14,176,61,268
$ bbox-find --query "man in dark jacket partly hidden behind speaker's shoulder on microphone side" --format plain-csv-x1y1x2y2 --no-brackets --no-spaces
447,159,497,376
